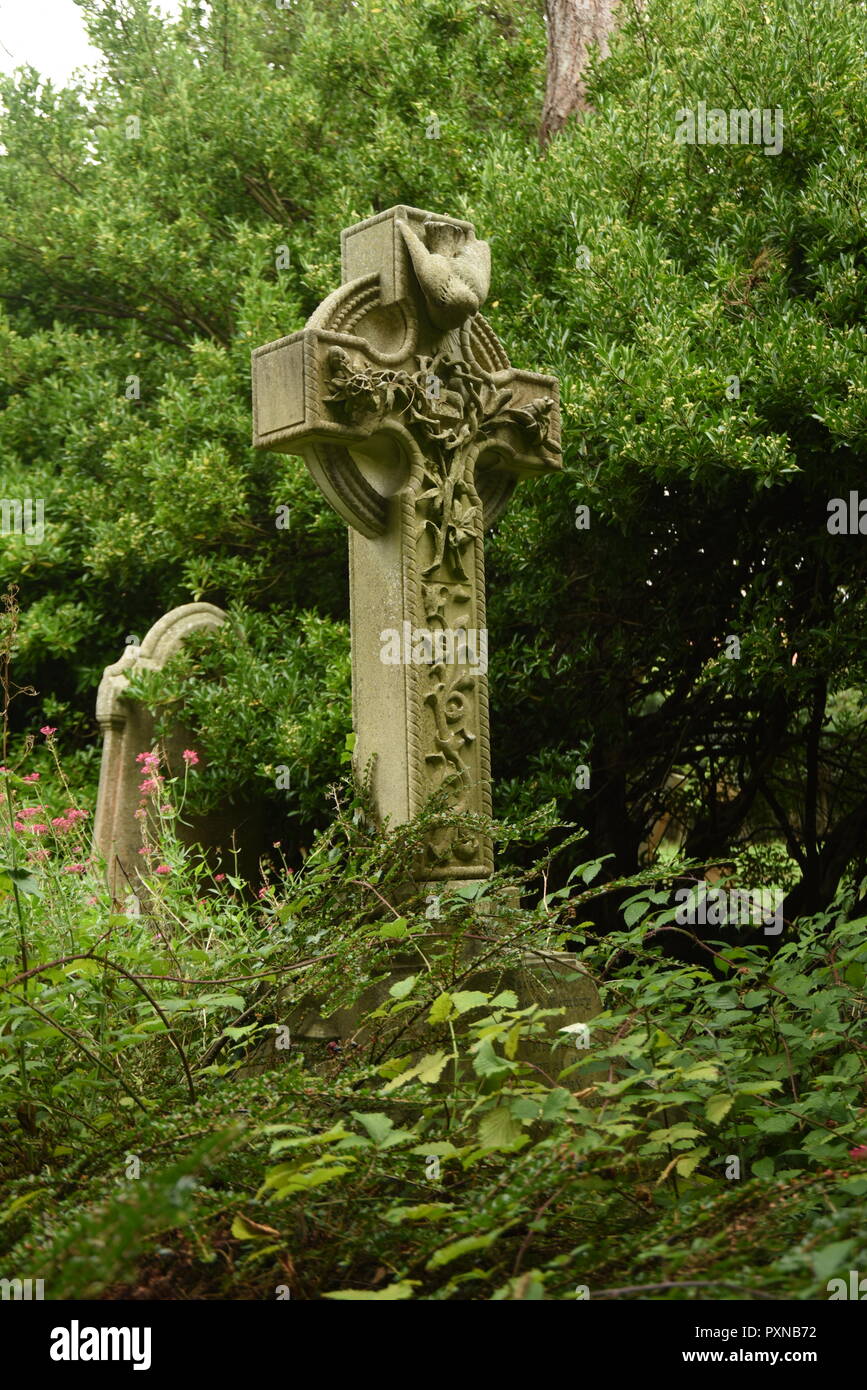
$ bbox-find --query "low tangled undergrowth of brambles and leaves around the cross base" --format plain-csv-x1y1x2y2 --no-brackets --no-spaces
0,689,867,1300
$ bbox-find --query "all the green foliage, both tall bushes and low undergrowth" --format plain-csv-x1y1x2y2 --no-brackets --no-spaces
0,0,867,1300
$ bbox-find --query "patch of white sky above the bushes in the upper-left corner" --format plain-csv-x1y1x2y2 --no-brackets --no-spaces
0,0,179,86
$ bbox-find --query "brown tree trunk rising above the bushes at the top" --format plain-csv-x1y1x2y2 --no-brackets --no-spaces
539,0,618,149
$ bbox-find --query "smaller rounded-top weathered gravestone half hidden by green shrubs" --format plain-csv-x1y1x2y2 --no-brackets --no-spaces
93,603,234,899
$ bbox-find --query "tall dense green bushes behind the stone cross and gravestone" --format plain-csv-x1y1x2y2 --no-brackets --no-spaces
0,0,867,916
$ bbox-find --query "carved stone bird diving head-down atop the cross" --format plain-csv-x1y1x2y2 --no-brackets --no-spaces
396,218,490,329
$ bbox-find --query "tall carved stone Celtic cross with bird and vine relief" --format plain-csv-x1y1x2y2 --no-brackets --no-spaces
253,207,560,881
